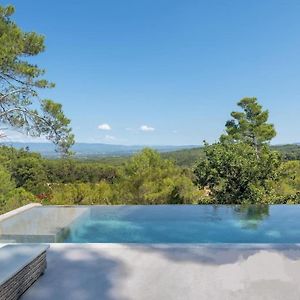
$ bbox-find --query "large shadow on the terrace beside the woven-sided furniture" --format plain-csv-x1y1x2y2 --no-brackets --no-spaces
22,246,128,300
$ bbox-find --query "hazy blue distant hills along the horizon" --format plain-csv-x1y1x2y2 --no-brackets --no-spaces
2,142,196,158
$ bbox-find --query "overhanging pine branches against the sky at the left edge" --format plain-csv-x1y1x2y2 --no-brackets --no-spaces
0,6,74,154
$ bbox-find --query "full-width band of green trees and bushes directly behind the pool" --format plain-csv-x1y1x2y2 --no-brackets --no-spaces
0,143,300,212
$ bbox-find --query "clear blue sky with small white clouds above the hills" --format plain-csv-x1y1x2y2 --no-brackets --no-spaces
4,0,300,145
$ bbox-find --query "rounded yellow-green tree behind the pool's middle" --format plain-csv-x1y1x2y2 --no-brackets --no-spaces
115,149,200,204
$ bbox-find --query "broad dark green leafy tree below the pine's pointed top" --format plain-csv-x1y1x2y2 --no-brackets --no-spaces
195,142,281,204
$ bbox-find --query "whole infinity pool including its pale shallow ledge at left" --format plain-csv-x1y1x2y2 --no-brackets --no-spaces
0,205,300,243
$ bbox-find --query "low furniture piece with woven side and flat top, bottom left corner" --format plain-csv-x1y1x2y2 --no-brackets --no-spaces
0,244,49,300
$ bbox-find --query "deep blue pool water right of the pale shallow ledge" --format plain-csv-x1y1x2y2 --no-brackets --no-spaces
66,206,300,243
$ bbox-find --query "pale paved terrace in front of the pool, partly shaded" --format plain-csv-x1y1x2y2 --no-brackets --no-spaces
22,244,300,300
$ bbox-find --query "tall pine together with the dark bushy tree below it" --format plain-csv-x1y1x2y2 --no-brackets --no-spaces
195,98,281,204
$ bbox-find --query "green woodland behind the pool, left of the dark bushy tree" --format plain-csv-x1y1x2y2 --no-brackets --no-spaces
0,146,203,212
